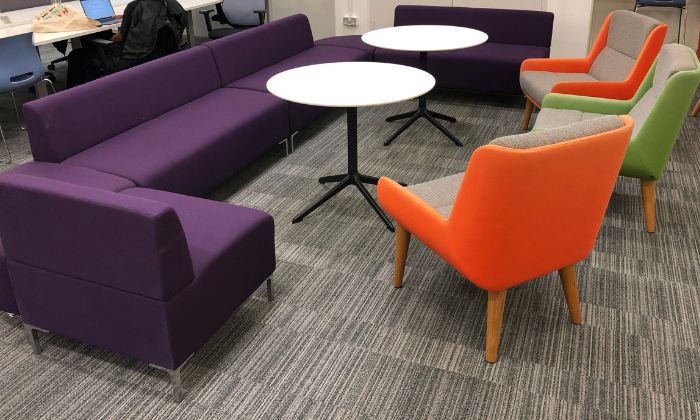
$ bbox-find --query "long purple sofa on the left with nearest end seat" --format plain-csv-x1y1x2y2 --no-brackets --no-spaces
0,15,371,398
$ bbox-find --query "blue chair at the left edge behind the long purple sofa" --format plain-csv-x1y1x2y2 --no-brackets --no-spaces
0,34,55,163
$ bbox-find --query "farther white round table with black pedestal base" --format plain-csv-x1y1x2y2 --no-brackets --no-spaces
362,25,489,146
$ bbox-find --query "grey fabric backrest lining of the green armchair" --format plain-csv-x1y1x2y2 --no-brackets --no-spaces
630,44,696,136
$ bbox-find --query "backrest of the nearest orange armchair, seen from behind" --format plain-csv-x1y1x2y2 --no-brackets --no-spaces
447,116,632,290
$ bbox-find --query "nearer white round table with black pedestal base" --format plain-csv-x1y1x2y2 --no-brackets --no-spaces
267,62,435,232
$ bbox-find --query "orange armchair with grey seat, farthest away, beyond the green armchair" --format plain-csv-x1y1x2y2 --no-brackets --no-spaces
520,10,668,130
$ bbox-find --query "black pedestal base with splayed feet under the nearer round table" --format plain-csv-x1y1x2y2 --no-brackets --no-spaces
292,107,394,232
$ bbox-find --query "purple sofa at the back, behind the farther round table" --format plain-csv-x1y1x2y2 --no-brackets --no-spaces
317,6,554,95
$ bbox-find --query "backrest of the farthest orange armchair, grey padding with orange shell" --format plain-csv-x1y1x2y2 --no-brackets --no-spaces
589,10,667,85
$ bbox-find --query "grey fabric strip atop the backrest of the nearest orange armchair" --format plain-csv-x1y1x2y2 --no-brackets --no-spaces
489,115,624,149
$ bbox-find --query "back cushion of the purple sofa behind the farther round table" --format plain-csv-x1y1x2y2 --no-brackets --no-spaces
394,6,554,48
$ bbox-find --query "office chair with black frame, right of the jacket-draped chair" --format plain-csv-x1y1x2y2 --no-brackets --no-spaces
199,0,270,39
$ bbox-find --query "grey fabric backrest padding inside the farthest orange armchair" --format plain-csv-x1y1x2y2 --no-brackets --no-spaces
589,10,661,81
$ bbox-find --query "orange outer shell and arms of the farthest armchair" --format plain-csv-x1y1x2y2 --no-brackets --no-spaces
520,14,668,108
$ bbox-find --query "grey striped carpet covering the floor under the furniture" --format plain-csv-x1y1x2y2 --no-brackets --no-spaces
0,47,700,419
